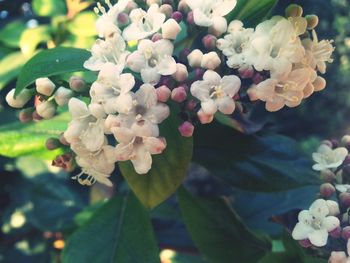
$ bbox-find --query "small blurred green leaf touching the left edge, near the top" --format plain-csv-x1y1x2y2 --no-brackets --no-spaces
0,20,27,48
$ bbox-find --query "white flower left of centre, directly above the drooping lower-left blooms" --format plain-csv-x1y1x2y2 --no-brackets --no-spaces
90,63,135,114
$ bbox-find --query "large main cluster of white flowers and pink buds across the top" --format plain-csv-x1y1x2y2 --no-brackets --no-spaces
3,0,334,188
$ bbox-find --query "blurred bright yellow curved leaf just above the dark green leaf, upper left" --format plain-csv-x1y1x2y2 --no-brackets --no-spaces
19,26,51,56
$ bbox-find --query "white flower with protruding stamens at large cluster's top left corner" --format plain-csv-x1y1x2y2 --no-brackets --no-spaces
95,0,130,38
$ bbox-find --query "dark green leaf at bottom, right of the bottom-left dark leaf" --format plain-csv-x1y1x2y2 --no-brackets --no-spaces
178,188,271,263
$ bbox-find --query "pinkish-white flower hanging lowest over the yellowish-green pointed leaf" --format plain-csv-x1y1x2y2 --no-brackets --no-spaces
112,127,166,174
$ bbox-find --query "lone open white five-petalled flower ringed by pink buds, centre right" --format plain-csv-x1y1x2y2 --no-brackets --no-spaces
191,70,241,116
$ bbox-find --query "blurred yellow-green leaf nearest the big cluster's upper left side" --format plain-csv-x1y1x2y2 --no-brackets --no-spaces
68,12,97,37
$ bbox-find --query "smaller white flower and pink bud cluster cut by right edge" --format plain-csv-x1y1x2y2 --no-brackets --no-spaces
292,135,350,263
